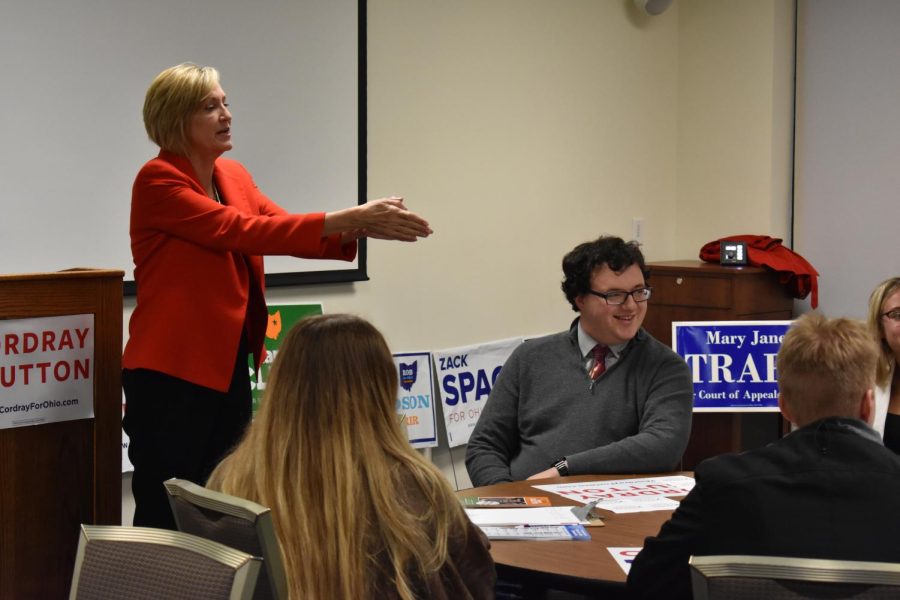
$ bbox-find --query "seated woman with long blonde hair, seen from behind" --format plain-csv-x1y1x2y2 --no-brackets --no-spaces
207,315,495,600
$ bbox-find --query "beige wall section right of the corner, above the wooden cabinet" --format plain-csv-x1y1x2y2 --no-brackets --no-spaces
676,0,794,258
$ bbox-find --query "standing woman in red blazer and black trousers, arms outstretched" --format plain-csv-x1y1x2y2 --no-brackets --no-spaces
122,63,431,529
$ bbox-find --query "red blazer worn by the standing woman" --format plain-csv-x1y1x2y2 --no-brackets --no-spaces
122,151,356,391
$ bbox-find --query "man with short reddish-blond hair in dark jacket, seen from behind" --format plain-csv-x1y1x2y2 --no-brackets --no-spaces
628,314,900,600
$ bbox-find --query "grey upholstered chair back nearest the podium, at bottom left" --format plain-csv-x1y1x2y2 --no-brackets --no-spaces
69,525,260,600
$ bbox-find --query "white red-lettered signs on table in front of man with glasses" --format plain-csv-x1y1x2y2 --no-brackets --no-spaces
534,475,694,513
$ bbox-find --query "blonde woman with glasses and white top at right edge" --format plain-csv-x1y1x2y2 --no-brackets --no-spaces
867,277,900,454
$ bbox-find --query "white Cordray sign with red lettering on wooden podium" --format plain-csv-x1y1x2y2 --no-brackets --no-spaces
0,314,94,429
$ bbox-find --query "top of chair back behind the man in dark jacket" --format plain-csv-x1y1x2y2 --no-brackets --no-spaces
690,555,900,600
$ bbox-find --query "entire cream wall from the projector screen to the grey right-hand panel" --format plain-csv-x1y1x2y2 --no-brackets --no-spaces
119,0,793,512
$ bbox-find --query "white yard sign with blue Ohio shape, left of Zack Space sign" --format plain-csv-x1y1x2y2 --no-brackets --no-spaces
394,352,437,448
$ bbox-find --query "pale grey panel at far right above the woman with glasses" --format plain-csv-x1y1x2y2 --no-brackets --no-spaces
793,0,900,318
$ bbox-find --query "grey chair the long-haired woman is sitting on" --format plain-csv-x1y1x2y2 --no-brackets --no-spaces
165,479,288,600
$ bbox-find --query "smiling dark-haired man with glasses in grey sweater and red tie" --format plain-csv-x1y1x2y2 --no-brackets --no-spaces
466,237,693,486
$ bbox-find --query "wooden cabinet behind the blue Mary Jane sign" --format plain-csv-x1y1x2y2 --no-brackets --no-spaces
644,260,793,470
